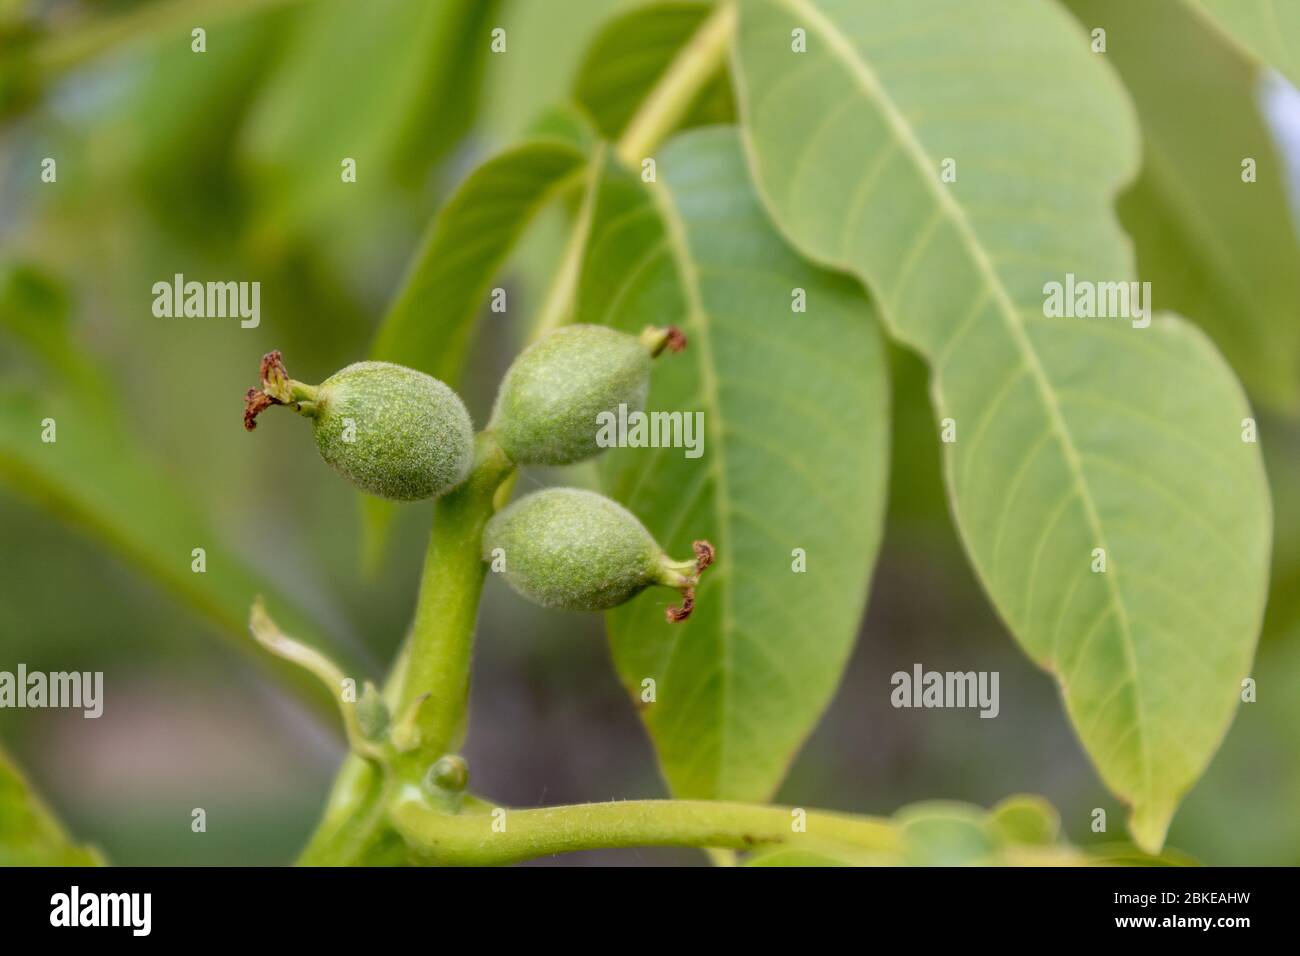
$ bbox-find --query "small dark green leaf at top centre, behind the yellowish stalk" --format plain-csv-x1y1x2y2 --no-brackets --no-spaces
573,0,735,140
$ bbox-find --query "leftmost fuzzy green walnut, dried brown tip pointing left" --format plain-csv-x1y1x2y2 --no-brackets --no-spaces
244,351,475,501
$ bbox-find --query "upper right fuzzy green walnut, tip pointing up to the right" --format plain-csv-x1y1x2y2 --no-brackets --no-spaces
488,325,686,464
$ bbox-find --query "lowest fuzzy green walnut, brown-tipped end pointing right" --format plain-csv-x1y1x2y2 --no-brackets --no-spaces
482,488,714,622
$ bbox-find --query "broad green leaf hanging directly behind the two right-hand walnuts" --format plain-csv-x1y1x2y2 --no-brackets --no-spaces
576,129,889,799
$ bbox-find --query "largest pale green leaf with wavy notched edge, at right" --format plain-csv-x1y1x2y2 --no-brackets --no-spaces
736,0,1270,849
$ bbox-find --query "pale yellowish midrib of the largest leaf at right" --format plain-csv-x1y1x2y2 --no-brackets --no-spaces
779,0,1152,800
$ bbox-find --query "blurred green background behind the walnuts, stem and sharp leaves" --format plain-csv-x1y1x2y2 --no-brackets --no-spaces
0,0,1300,865
